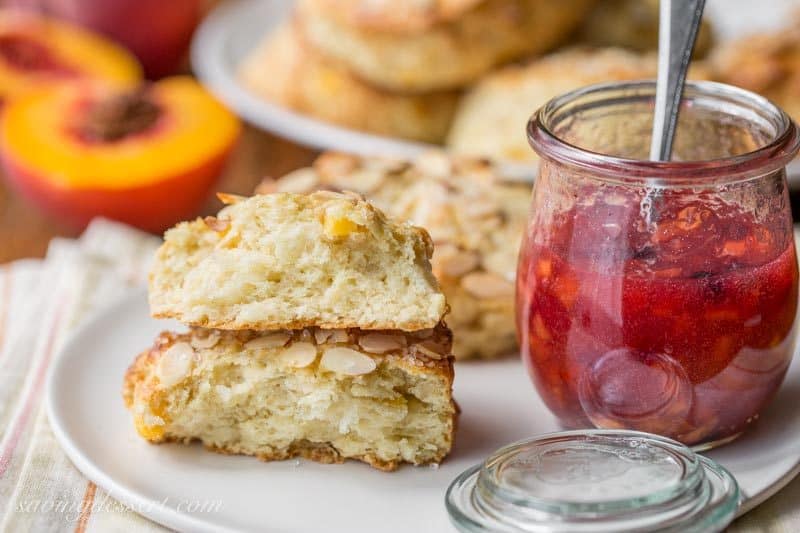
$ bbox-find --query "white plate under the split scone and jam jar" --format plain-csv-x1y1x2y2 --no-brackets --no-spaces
47,291,800,533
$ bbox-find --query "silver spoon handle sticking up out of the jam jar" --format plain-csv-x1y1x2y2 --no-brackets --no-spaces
650,0,705,161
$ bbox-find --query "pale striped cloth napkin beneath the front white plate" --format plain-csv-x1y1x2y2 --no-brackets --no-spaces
0,220,800,533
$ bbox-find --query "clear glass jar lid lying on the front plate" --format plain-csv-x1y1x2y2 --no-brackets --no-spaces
445,430,739,533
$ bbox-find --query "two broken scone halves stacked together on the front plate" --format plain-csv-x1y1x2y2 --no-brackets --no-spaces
128,192,456,470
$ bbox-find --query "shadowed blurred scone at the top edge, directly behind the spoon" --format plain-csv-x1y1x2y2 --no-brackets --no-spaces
578,0,714,58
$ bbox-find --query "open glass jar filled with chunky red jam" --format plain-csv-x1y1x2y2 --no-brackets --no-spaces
517,82,799,448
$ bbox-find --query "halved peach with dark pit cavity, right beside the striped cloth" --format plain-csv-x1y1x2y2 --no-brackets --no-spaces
0,77,240,232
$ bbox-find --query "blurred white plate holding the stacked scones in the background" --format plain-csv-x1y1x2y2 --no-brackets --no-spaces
191,0,800,185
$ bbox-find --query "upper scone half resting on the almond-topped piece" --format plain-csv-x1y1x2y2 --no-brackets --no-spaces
149,191,447,331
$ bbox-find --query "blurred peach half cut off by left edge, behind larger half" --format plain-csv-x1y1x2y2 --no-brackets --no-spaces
0,9,142,102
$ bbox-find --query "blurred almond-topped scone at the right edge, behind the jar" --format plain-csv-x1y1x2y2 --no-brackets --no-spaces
711,23,800,121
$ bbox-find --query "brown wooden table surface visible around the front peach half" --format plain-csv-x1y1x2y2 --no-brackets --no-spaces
0,127,316,264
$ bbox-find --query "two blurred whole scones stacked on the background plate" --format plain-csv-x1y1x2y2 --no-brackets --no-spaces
240,0,593,143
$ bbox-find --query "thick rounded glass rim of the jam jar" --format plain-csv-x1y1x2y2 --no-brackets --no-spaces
527,80,800,187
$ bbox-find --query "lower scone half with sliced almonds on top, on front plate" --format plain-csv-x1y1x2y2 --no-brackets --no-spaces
123,324,455,470
